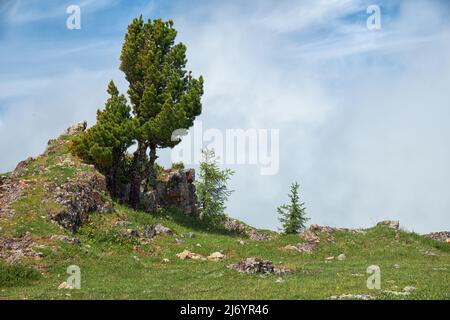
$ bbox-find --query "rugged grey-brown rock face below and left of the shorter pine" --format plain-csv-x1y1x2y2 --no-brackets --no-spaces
51,172,112,231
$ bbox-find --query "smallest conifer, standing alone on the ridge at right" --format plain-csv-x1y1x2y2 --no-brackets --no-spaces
277,182,309,233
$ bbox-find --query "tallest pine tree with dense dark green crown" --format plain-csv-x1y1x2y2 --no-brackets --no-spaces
120,16,203,208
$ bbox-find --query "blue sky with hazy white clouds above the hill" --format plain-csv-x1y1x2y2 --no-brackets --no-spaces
0,0,450,232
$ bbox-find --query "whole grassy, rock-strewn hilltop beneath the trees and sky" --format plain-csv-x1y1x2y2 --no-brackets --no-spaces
0,125,450,299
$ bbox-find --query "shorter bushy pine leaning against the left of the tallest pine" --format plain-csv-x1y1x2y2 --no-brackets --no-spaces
72,81,134,196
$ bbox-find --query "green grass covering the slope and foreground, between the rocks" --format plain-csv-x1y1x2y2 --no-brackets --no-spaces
0,134,450,299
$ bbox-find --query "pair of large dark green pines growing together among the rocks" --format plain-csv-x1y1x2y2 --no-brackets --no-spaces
73,16,203,208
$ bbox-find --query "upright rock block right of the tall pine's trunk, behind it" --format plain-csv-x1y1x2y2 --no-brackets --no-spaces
141,169,197,215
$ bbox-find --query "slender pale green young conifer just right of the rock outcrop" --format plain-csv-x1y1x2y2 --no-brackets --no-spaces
196,149,234,225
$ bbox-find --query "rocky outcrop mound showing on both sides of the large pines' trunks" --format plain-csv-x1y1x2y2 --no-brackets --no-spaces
0,122,197,231
